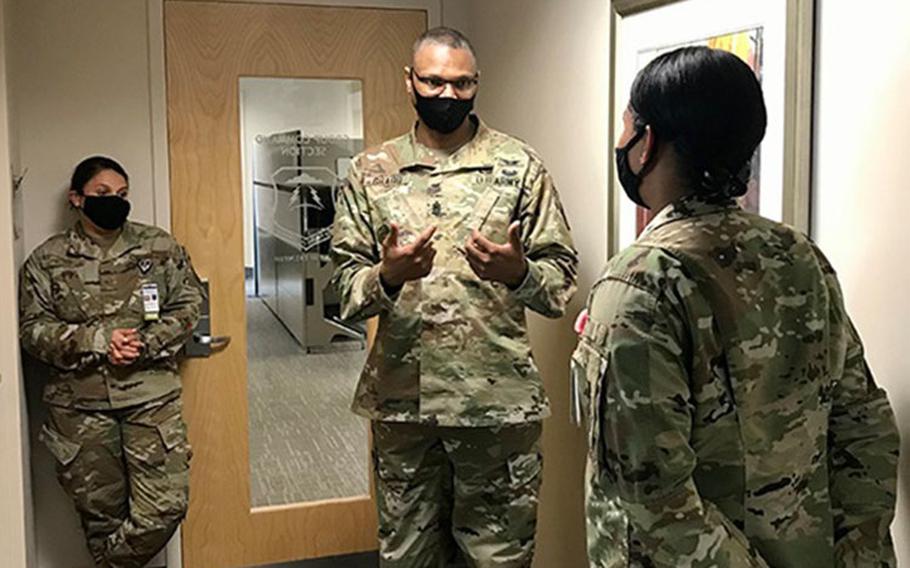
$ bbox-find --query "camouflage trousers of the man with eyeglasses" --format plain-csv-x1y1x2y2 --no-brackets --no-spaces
373,421,542,568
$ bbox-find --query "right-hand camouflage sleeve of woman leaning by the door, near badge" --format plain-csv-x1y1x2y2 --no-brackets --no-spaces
140,243,203,361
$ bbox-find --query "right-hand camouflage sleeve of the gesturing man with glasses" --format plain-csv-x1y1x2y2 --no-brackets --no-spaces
514,167,578,318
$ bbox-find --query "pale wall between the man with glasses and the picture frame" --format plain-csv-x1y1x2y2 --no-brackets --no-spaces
443,0,612,568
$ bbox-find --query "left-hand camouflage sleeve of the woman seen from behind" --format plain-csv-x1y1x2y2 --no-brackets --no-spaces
591,274,767,568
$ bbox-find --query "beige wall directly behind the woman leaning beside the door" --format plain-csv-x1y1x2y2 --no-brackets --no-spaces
0,0,155,568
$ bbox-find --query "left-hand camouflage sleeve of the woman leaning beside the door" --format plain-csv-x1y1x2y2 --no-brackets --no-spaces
19,255,112,371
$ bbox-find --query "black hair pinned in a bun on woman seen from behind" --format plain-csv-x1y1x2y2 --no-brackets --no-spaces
629,47,768,198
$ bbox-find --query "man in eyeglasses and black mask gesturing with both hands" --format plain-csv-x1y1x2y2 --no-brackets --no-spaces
332,28,578,568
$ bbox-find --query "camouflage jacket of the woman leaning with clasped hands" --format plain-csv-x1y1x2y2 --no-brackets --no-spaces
19,222,202,410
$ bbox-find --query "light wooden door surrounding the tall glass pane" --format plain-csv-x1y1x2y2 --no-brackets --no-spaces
165,0,427,568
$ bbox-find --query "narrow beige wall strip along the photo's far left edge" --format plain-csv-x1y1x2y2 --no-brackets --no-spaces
0,2,29,567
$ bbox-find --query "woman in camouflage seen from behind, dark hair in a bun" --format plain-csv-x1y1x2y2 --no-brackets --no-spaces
572,48,898,568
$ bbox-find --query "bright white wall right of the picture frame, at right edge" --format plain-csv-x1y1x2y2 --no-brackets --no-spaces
812,0,910,566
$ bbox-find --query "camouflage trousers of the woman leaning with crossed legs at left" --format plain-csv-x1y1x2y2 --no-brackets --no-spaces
42,393,191,568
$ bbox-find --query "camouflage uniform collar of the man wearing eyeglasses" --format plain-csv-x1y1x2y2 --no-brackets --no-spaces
398,114,493,172
